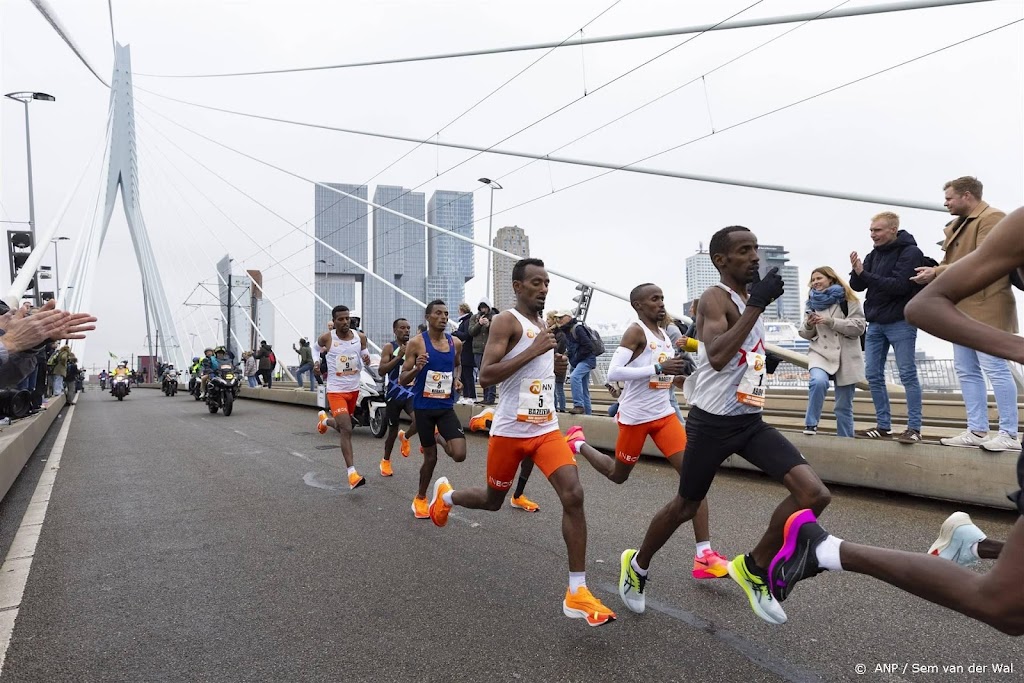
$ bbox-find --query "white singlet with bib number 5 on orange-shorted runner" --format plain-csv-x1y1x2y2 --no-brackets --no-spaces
490,308,558,438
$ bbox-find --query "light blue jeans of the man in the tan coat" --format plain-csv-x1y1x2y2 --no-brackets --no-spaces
953,344,1017,438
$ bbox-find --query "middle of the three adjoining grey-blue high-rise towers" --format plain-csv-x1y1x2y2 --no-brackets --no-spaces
361,185,427,346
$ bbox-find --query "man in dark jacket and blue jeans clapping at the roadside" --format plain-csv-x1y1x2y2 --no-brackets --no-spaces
850,211,925,443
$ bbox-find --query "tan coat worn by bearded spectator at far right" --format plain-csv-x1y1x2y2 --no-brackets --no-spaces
936,202,1017,333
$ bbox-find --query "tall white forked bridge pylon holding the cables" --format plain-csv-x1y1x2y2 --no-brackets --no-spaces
58,43,187,368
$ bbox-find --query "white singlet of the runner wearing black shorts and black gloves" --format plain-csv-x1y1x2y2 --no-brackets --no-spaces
685,283,766,415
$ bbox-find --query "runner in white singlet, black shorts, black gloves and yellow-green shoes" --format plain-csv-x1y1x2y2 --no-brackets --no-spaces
618,225,829,624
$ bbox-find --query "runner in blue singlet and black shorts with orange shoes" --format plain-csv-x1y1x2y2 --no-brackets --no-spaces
398,299,466,519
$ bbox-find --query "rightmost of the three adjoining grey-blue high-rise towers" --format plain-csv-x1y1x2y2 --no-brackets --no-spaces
424,189,476,311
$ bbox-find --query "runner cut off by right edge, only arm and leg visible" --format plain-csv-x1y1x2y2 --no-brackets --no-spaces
769,209,1024,636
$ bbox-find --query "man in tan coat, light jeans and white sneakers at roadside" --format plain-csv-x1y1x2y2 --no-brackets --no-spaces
913,176,1021,452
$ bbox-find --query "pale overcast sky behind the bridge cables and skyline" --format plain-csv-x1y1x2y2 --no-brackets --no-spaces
0,0,1024,368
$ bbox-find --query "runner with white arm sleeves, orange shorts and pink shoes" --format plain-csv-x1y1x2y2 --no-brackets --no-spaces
565,283,729,579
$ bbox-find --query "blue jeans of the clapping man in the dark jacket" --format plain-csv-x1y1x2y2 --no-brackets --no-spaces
864,321,921,431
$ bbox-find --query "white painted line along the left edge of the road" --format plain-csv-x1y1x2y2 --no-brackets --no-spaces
0,405,75,674
